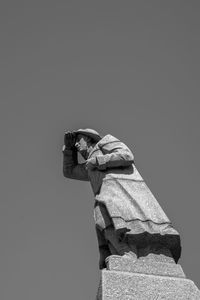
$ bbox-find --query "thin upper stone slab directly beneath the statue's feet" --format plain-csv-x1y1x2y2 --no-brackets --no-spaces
107,255,185,278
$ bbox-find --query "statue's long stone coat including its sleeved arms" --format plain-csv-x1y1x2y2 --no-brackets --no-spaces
63,134,181,261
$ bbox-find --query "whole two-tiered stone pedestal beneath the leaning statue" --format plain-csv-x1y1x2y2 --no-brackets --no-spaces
97,257,200,300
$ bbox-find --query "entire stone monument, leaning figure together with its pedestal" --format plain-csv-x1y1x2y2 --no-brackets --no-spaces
63,128,200,300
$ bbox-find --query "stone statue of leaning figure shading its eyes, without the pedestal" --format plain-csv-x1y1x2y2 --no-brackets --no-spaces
63,129,181,269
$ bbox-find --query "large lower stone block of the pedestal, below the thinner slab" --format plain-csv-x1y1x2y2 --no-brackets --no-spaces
97,270,200,300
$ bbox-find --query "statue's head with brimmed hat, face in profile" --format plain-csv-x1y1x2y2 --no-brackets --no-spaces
73,128,102,158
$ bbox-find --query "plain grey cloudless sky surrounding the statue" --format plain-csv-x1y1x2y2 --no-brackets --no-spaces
0,0,200,300
